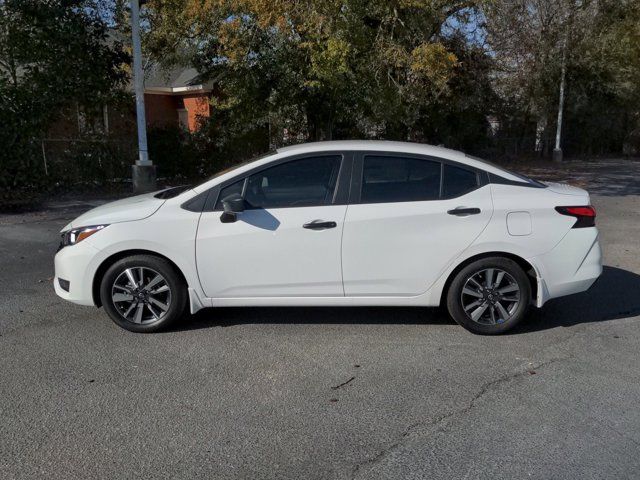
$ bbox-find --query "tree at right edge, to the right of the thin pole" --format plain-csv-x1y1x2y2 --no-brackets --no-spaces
565,0,640,155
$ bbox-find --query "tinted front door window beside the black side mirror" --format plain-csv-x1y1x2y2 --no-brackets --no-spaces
216,155,342,210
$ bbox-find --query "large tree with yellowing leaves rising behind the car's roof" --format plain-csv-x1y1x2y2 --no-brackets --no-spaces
146,0,482,144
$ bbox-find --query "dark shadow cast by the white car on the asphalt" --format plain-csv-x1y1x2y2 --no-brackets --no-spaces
169,267,640,334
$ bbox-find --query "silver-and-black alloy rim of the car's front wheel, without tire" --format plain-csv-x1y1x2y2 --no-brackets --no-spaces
111,267,171,324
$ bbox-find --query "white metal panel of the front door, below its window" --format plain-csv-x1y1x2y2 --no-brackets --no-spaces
196,205,347,298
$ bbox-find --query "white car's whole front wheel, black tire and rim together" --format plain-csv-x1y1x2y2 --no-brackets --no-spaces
100,255,188,333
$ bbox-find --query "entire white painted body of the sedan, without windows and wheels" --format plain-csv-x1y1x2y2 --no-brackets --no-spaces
54,141,602,312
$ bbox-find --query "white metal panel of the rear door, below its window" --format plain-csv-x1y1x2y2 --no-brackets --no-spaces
342,185,493,296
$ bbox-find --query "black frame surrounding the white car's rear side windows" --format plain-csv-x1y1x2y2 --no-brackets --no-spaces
349,150,490,205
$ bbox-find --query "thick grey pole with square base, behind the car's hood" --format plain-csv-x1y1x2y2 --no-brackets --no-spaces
130,0,156,193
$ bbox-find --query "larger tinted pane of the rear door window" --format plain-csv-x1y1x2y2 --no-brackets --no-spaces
360,155,441,203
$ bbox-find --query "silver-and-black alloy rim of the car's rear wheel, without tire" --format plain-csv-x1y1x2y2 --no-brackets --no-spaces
460,268,521,325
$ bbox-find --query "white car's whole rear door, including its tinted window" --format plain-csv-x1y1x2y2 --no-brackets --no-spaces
342,152,493,296
